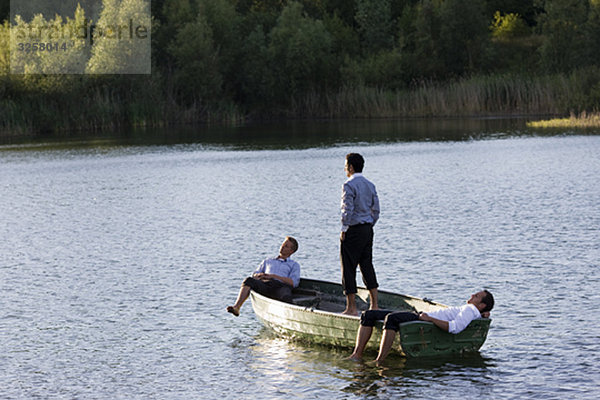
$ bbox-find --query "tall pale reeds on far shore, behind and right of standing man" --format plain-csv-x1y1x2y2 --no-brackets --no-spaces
289,76,574,118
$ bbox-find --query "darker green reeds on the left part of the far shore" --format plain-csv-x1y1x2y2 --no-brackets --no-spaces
0,77,245,137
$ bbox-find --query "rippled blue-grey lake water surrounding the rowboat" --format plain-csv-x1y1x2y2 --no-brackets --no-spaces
0,120,600,399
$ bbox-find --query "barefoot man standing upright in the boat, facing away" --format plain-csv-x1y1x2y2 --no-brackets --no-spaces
340,153,379,315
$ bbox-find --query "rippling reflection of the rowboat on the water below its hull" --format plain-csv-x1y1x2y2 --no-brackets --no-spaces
248,328,495,397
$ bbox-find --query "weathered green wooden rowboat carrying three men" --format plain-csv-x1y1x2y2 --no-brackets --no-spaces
250,279,491,357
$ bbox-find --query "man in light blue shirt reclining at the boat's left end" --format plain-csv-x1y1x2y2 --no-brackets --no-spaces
227,236,300,317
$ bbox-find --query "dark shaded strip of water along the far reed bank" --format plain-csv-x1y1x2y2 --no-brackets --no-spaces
0,118,584,150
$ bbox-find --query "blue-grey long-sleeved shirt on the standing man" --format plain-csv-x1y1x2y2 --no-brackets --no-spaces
342,172,379,232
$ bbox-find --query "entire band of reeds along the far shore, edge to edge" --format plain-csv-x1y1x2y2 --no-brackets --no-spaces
0,69,600,136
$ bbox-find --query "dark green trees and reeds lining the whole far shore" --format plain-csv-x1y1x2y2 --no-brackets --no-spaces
0,0,600,132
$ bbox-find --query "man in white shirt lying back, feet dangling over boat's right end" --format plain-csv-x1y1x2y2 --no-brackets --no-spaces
349,290,494,365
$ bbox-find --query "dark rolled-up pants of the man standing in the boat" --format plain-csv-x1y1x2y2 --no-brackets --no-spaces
340,224,379,294
